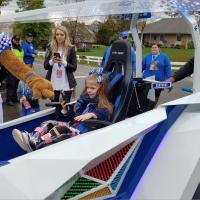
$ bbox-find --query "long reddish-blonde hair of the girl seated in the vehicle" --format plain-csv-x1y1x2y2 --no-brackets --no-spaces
81,73,113,114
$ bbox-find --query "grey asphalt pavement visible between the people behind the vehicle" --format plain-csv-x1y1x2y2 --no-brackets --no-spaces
1,60,192,122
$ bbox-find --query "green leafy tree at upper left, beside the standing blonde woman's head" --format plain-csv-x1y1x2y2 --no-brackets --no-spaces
14,0,53,48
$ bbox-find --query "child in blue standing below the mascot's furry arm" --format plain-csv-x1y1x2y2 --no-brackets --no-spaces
17,81,40,116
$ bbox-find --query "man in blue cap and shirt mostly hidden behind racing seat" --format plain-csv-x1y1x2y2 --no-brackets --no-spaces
100,32,136,72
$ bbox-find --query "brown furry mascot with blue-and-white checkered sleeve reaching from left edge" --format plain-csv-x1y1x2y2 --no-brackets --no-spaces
0,33,54,123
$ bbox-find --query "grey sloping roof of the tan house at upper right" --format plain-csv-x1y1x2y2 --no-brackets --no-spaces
144,18,191,34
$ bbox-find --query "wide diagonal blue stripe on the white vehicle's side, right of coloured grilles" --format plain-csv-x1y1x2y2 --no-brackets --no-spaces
108,105,187,200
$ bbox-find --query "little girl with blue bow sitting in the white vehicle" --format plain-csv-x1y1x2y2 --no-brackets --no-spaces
12,69,113,152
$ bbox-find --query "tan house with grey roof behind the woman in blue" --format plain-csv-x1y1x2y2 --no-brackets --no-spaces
143,18,193,49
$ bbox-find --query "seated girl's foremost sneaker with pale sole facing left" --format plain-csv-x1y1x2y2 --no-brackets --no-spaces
12,129,33,152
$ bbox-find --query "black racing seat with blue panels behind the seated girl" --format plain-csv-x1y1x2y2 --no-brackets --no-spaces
103,40,133,123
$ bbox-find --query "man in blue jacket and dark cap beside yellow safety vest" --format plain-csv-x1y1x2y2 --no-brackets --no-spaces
22,33,37,67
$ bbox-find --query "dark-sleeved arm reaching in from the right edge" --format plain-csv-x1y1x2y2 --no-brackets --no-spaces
170,58,194,82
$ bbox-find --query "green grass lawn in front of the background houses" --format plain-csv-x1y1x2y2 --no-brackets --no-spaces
77,46,194,62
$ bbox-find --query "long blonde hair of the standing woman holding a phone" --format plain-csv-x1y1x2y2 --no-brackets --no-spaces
50,26,74,58
